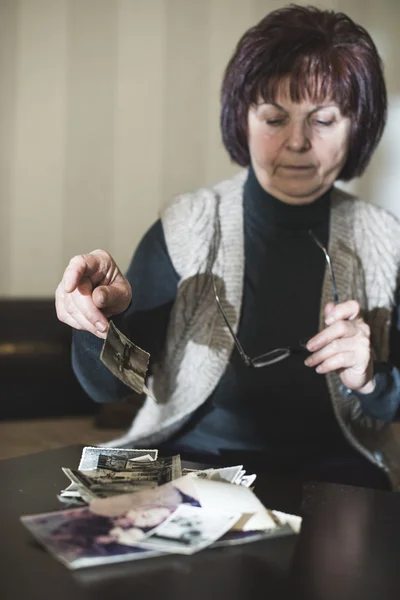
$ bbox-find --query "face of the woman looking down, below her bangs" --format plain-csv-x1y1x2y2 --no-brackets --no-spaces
248,84,350,204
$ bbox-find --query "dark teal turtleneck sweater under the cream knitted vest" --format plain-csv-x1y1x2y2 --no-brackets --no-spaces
73,170,398,470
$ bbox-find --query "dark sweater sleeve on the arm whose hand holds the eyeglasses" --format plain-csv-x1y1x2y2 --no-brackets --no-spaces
353,292,400,422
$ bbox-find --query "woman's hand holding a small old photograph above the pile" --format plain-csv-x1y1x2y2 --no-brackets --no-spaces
56,250,132,338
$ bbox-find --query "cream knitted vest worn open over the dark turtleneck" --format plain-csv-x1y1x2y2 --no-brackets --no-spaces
112,172,400,487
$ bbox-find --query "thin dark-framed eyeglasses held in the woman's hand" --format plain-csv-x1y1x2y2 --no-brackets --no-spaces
209,230,339,369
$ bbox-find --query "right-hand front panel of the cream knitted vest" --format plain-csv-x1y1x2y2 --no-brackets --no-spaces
320,189,400,489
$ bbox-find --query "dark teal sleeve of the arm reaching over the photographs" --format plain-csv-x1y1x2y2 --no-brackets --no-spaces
72,220,179,402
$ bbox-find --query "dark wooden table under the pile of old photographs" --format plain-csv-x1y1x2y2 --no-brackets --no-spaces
0,446,400,600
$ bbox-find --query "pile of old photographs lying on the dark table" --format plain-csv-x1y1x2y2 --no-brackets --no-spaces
21,447,301,569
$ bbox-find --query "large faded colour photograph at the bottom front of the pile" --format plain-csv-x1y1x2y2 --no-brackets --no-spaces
21,485,199,569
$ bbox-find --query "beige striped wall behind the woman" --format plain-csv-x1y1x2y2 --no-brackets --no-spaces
0,0,400,297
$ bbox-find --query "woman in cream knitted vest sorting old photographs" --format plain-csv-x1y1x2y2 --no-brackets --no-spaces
56,5,400,489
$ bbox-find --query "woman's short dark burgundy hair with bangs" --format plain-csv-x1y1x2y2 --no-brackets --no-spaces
221,4,387,181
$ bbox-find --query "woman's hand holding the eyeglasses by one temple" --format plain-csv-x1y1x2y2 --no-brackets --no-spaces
305,300,375,394
